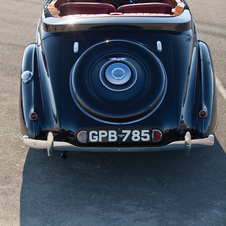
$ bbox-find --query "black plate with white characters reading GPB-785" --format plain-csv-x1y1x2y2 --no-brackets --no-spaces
88,129,151,143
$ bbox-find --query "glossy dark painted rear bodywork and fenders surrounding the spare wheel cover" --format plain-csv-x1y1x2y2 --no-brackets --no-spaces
20,2,216,146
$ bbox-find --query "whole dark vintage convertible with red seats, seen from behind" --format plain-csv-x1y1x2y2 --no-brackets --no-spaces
19,0,217,158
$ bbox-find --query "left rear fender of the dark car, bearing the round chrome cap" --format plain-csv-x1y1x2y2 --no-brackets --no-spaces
19,44,43,138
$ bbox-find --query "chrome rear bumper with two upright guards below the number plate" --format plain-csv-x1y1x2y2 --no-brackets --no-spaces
23,132,214,156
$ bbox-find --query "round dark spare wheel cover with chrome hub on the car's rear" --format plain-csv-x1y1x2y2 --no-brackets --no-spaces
70,40,167,124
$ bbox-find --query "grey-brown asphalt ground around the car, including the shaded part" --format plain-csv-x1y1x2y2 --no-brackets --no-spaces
0,0,226,226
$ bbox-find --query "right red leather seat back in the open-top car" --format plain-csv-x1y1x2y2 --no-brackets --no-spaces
117,2,172,14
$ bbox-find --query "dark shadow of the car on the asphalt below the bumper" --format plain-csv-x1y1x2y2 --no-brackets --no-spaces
20,139,226,226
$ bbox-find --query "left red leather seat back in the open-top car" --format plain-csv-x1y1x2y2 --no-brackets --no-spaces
58,2,116,16
